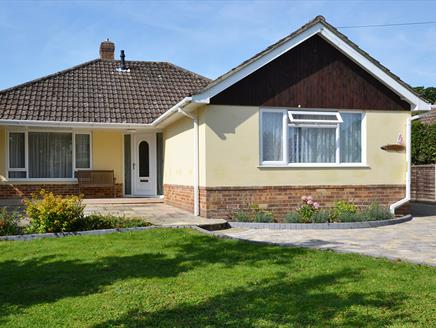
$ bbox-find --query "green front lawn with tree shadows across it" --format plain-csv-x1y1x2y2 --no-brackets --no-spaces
0,229,436,327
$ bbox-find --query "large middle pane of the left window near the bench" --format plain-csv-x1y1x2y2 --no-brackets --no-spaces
29,132,72,178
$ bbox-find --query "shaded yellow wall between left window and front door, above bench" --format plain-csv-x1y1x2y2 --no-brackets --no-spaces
92,130,124,183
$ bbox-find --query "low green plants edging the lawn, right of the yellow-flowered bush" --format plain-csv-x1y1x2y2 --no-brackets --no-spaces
71,214,150,231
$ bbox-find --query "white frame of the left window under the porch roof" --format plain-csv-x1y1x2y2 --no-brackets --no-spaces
5,128,93,182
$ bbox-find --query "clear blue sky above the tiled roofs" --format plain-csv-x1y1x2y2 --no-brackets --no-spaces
0,1,436,89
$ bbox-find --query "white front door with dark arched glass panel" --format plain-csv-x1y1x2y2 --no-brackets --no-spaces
132,133,157,196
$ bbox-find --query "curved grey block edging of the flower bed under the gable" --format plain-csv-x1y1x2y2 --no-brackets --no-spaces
228,214,413,230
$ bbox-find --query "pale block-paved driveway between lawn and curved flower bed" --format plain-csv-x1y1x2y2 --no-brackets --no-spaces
219,216,436,266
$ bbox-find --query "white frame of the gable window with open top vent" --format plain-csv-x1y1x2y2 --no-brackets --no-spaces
259,107,368,168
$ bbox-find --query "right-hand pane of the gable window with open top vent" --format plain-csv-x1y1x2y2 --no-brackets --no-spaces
340,113,362,163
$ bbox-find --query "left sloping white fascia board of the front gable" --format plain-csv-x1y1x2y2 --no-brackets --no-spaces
192,23,322,103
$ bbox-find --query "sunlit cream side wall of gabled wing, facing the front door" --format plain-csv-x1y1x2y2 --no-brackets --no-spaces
163,117,194,185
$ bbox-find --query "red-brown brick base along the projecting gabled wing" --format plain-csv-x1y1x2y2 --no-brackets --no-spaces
164,185,408,219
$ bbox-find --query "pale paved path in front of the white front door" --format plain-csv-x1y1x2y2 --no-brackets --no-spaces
85,201,226,225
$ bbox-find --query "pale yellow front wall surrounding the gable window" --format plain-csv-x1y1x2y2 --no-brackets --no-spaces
201,105,410,187
